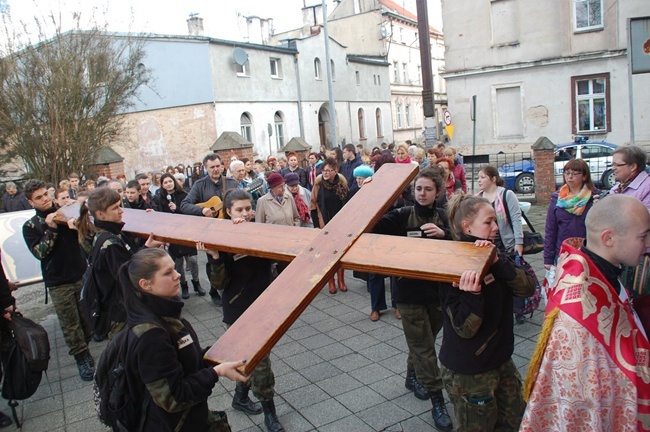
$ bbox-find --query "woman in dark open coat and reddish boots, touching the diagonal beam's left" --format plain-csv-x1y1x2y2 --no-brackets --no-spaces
309,158,348,294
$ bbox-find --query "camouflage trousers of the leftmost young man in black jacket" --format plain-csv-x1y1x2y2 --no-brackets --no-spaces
49,280,93,355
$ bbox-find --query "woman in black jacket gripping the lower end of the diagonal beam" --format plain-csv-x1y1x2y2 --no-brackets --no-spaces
119,249,247,432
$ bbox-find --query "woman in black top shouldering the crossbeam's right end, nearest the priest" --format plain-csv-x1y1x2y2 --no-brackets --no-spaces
439,194,535,431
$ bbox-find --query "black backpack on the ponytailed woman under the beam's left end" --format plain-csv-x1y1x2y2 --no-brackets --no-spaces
81,232,115,336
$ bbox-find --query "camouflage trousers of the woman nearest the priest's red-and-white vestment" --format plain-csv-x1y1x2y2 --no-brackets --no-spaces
442,360,526,432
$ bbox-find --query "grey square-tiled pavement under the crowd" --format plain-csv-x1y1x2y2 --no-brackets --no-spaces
10,206,546,432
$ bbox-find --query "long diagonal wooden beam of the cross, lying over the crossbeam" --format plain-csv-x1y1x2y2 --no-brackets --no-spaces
205,164,417,375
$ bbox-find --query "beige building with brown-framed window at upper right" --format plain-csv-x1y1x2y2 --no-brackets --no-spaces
442,0,650,154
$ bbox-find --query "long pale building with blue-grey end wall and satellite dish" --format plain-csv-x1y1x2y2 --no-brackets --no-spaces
112,20,393,177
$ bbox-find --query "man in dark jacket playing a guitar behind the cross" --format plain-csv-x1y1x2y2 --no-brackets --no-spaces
181,153,237,306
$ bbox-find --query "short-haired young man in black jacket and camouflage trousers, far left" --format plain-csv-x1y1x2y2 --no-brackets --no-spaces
23,180,95,381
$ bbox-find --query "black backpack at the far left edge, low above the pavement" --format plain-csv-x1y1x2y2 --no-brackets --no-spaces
2,312,50,428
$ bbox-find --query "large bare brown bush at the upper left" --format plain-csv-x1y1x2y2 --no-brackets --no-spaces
0,13,151,182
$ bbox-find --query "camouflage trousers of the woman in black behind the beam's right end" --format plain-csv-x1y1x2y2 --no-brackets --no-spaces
397,302,443,392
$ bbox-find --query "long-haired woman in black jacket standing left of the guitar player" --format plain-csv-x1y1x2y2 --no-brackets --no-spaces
153,173,205,299
